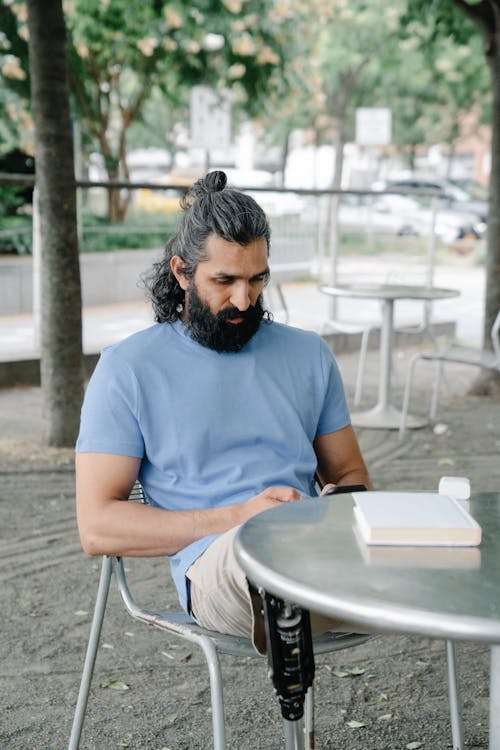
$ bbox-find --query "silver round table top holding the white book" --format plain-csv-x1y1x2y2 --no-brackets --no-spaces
235,493,500,643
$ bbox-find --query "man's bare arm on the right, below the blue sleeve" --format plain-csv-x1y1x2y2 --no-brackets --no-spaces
314,425,373,490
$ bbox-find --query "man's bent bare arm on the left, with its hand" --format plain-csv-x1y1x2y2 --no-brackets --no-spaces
75,453,299,557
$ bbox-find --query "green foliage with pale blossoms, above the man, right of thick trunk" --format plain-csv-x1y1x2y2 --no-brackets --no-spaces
67,0,292,169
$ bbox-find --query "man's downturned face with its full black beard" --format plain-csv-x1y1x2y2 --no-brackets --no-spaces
173,234,269,352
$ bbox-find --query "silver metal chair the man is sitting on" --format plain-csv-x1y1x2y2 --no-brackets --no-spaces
68,483,370,750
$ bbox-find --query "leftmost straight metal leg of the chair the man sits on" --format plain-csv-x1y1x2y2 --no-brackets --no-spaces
68,556,112,750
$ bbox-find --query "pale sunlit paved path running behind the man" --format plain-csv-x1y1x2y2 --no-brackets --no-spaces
0,258,484,362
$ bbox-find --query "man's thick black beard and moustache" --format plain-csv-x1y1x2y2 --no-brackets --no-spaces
186,284,264,352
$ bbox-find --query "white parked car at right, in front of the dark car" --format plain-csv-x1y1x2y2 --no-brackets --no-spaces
339,193,481,243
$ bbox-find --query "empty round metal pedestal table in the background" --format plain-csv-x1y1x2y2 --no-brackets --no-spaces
320,284,459,430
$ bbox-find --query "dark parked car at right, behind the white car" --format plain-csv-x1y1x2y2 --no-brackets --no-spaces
372,177,488,232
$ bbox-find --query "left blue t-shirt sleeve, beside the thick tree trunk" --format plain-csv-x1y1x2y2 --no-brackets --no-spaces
76,348,144,458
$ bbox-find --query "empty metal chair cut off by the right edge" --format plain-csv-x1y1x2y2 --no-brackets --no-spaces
399,310,500,438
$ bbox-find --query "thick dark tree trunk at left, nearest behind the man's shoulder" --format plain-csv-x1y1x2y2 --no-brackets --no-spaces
27,0,84,446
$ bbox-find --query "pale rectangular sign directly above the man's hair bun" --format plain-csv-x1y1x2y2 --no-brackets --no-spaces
190,86,231,151
